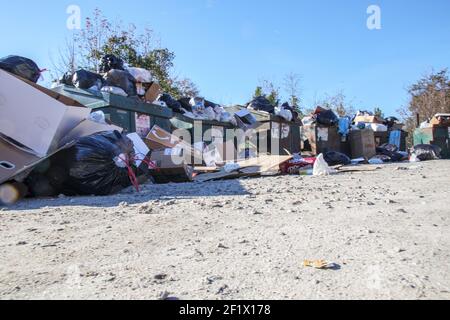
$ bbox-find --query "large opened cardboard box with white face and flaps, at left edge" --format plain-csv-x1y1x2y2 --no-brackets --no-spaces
0,70,122,184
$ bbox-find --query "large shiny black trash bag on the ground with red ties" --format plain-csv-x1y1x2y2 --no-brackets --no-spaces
57,131,134,196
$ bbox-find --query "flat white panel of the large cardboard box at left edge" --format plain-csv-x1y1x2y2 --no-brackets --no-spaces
0,70,91,157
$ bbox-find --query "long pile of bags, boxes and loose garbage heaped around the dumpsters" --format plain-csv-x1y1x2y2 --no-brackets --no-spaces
0,55,450,204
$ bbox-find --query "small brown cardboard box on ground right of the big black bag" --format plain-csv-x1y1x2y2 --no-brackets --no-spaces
150,148,194,184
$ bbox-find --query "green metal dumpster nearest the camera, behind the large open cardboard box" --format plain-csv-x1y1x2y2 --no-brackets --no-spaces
52,85,173,138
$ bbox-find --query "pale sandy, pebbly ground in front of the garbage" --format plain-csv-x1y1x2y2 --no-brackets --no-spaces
0,161,450,300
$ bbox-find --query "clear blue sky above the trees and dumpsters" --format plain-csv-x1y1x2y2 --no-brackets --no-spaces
0,0,450,115
